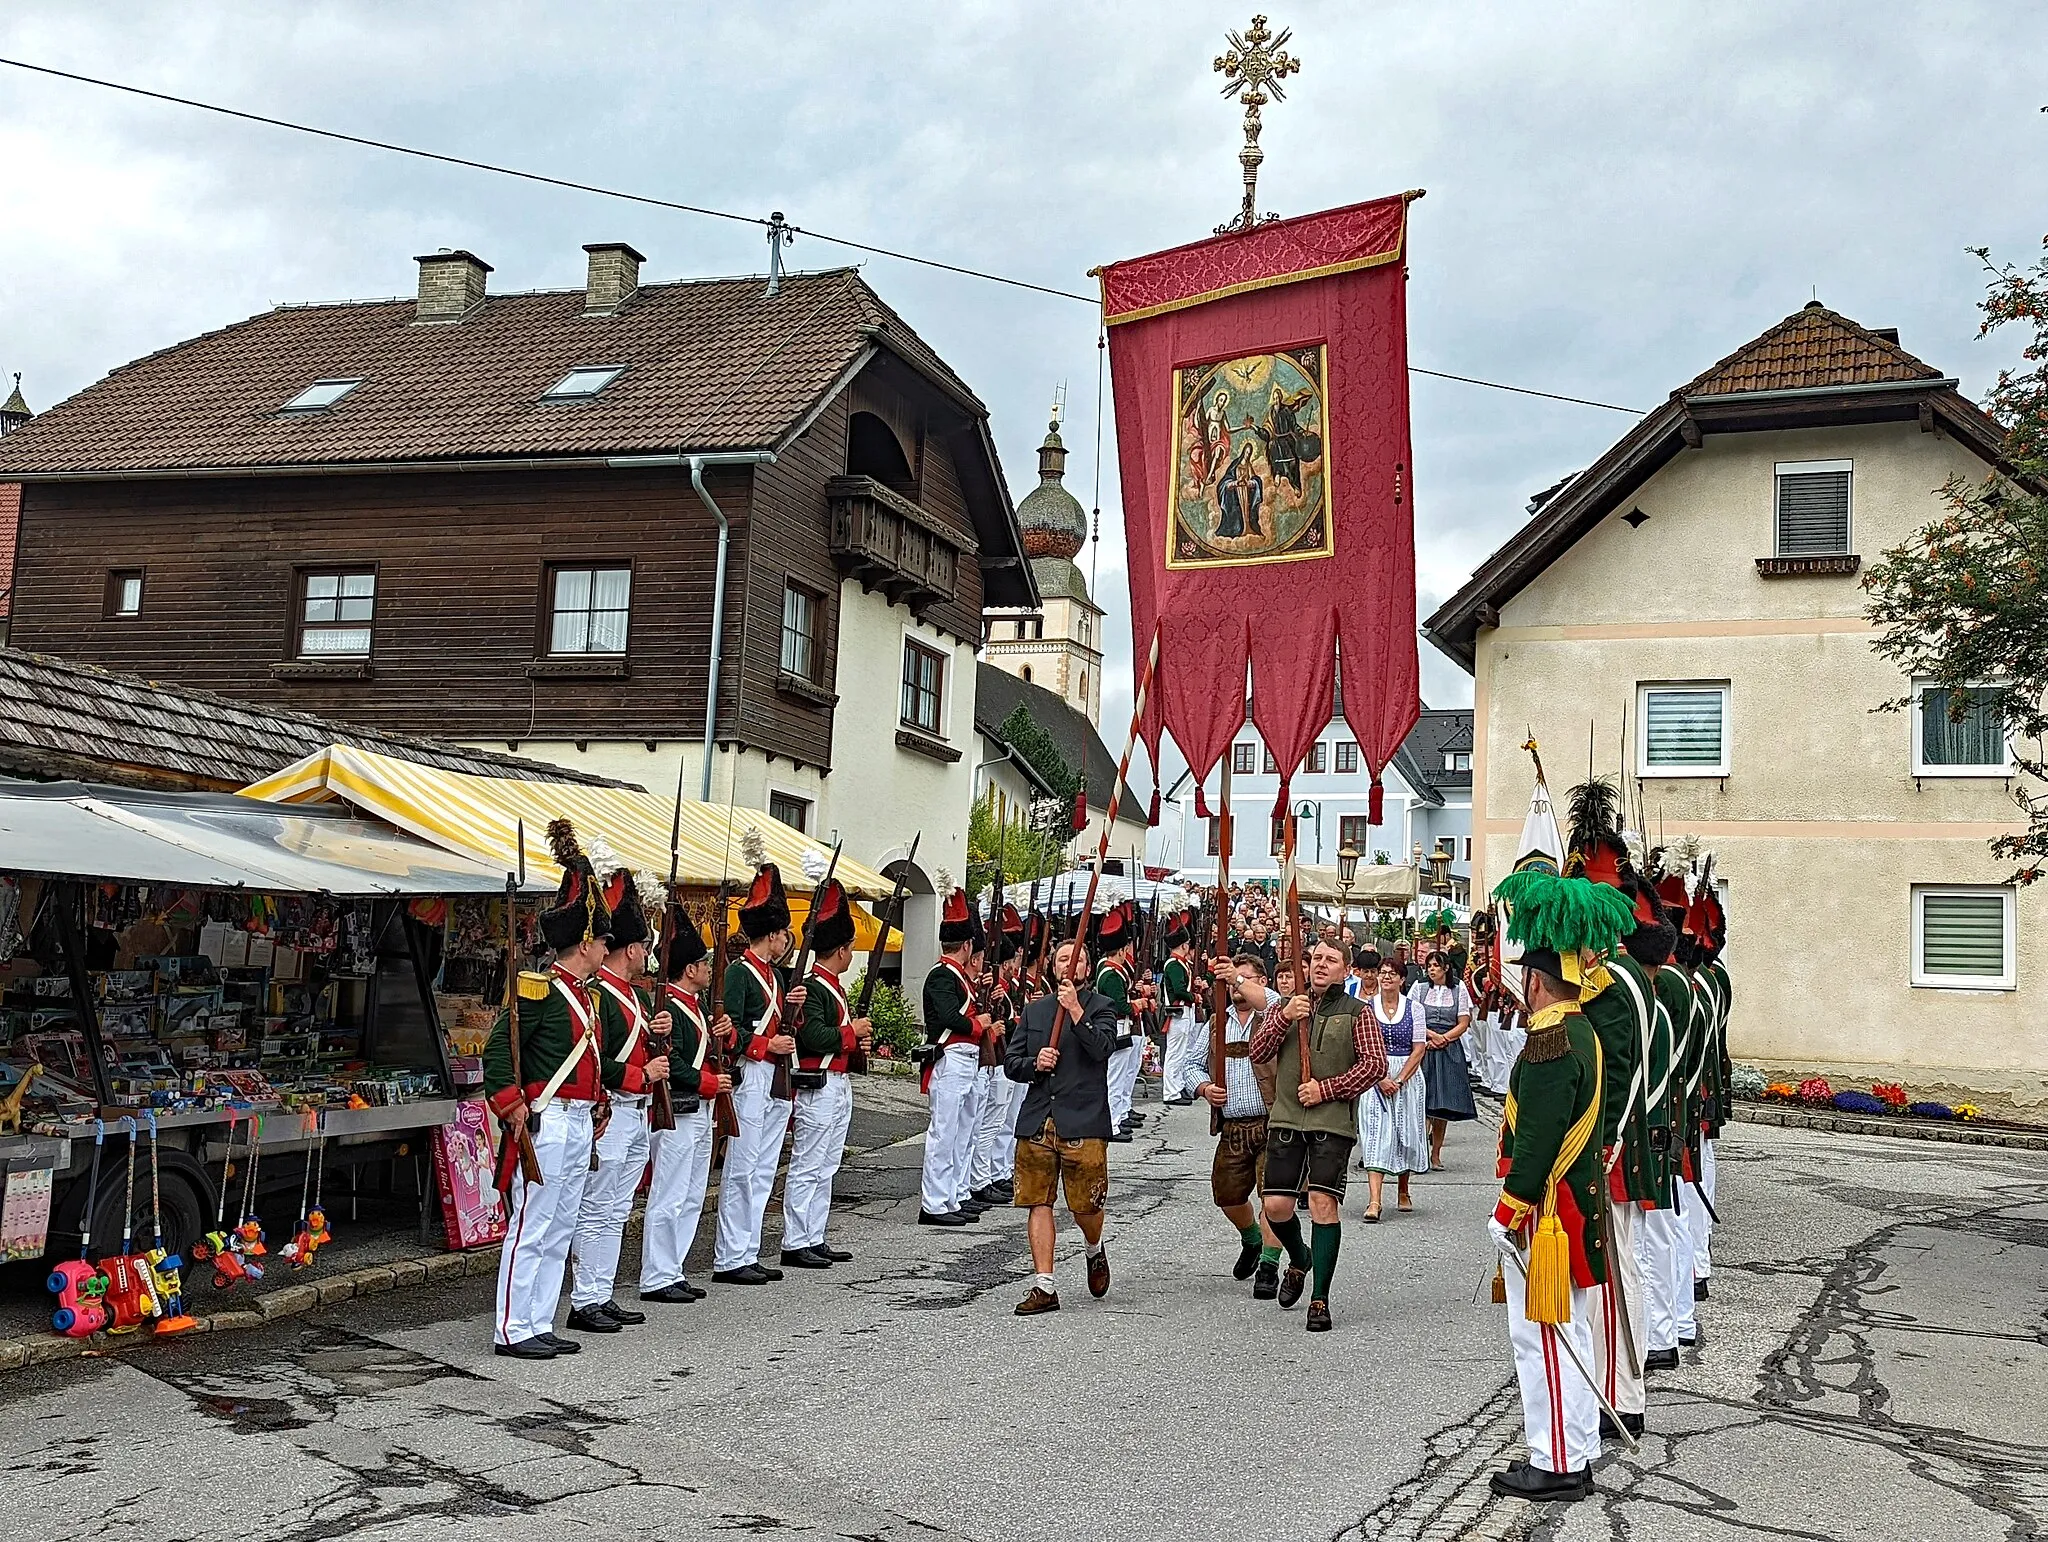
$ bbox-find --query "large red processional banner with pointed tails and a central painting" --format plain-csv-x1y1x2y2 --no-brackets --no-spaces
1100,197,1421,821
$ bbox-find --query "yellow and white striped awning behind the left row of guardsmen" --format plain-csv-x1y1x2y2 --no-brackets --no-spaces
242,743,895,896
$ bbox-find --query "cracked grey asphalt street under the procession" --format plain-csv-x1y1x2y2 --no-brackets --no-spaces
0,1085,2048,1542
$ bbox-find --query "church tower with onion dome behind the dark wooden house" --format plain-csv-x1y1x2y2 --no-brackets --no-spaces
983,408,1102,727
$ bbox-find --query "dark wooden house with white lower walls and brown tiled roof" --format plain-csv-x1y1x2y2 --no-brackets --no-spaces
0,244,1038,974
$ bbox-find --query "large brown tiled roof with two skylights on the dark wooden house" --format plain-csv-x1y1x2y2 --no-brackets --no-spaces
0,268,983,475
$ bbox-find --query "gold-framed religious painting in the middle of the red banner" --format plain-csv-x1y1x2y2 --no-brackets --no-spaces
1165,344,1331,567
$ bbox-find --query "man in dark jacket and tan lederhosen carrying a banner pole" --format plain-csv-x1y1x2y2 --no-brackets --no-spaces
1004,942,1116,1317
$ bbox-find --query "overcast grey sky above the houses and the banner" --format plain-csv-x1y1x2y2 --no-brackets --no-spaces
0,0,2048,782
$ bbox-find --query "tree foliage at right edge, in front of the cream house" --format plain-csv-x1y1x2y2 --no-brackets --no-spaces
1862,242,2048,885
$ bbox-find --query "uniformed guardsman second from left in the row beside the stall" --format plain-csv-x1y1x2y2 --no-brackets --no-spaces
569,868,672,1333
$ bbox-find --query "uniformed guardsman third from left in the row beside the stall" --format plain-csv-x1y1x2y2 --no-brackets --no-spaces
641,905,733,1304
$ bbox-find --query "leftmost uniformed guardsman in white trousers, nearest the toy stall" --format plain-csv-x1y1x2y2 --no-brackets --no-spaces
483,819,612,1360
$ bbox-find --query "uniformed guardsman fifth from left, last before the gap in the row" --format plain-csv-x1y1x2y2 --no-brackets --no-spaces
782,879,874,1270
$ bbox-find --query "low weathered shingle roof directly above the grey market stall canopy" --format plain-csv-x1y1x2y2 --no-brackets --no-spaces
0,647,627,788
